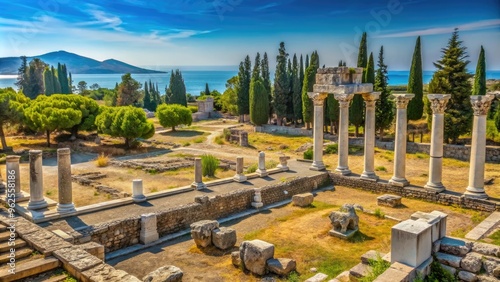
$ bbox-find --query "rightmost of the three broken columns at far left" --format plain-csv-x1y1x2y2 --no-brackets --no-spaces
57,148,75,213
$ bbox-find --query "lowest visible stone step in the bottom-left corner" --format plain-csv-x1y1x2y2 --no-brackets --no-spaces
0,257,61,282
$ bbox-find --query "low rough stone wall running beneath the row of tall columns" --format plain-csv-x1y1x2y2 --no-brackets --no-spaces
330,173,500,212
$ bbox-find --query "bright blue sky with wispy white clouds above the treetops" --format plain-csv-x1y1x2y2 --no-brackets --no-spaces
0,0,500,71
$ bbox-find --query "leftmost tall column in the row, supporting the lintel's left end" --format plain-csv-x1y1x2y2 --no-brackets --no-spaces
308,92,328,171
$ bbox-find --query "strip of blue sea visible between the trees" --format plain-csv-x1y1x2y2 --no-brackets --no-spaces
0,67,500,96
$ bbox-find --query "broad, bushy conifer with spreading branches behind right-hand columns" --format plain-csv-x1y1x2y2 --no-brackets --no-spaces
428,29,473,144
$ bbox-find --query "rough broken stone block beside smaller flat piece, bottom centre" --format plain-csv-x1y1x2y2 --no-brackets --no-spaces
240,240,274,275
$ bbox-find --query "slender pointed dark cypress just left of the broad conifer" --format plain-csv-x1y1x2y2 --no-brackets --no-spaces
406,36,424,120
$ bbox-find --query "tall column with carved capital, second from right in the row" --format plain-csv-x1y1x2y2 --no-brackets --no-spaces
424,94,451,192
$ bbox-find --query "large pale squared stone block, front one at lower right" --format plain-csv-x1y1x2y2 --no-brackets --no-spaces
391,220,432,267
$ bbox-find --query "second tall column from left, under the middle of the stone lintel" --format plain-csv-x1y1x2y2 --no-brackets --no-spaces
334,94,354,175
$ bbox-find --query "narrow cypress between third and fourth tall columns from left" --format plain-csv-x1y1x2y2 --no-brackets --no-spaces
373,46,394,140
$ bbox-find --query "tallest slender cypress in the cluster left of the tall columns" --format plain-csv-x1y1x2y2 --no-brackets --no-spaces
273,42,290,125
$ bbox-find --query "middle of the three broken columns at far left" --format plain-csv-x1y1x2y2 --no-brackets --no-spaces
28,150,48,210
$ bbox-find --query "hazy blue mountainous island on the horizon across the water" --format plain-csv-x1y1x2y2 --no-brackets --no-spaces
0,51,164,75
